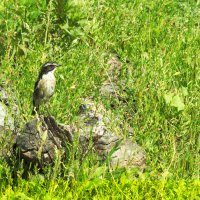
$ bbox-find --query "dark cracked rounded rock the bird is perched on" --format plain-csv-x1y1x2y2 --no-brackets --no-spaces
15,116,73,168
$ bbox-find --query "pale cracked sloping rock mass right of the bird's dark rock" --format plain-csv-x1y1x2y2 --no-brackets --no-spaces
79,99,145,171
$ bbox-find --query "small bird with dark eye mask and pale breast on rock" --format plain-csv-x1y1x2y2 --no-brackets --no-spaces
32,62,60,115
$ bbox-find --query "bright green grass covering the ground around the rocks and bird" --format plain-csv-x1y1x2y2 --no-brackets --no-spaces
0,0,200,199
